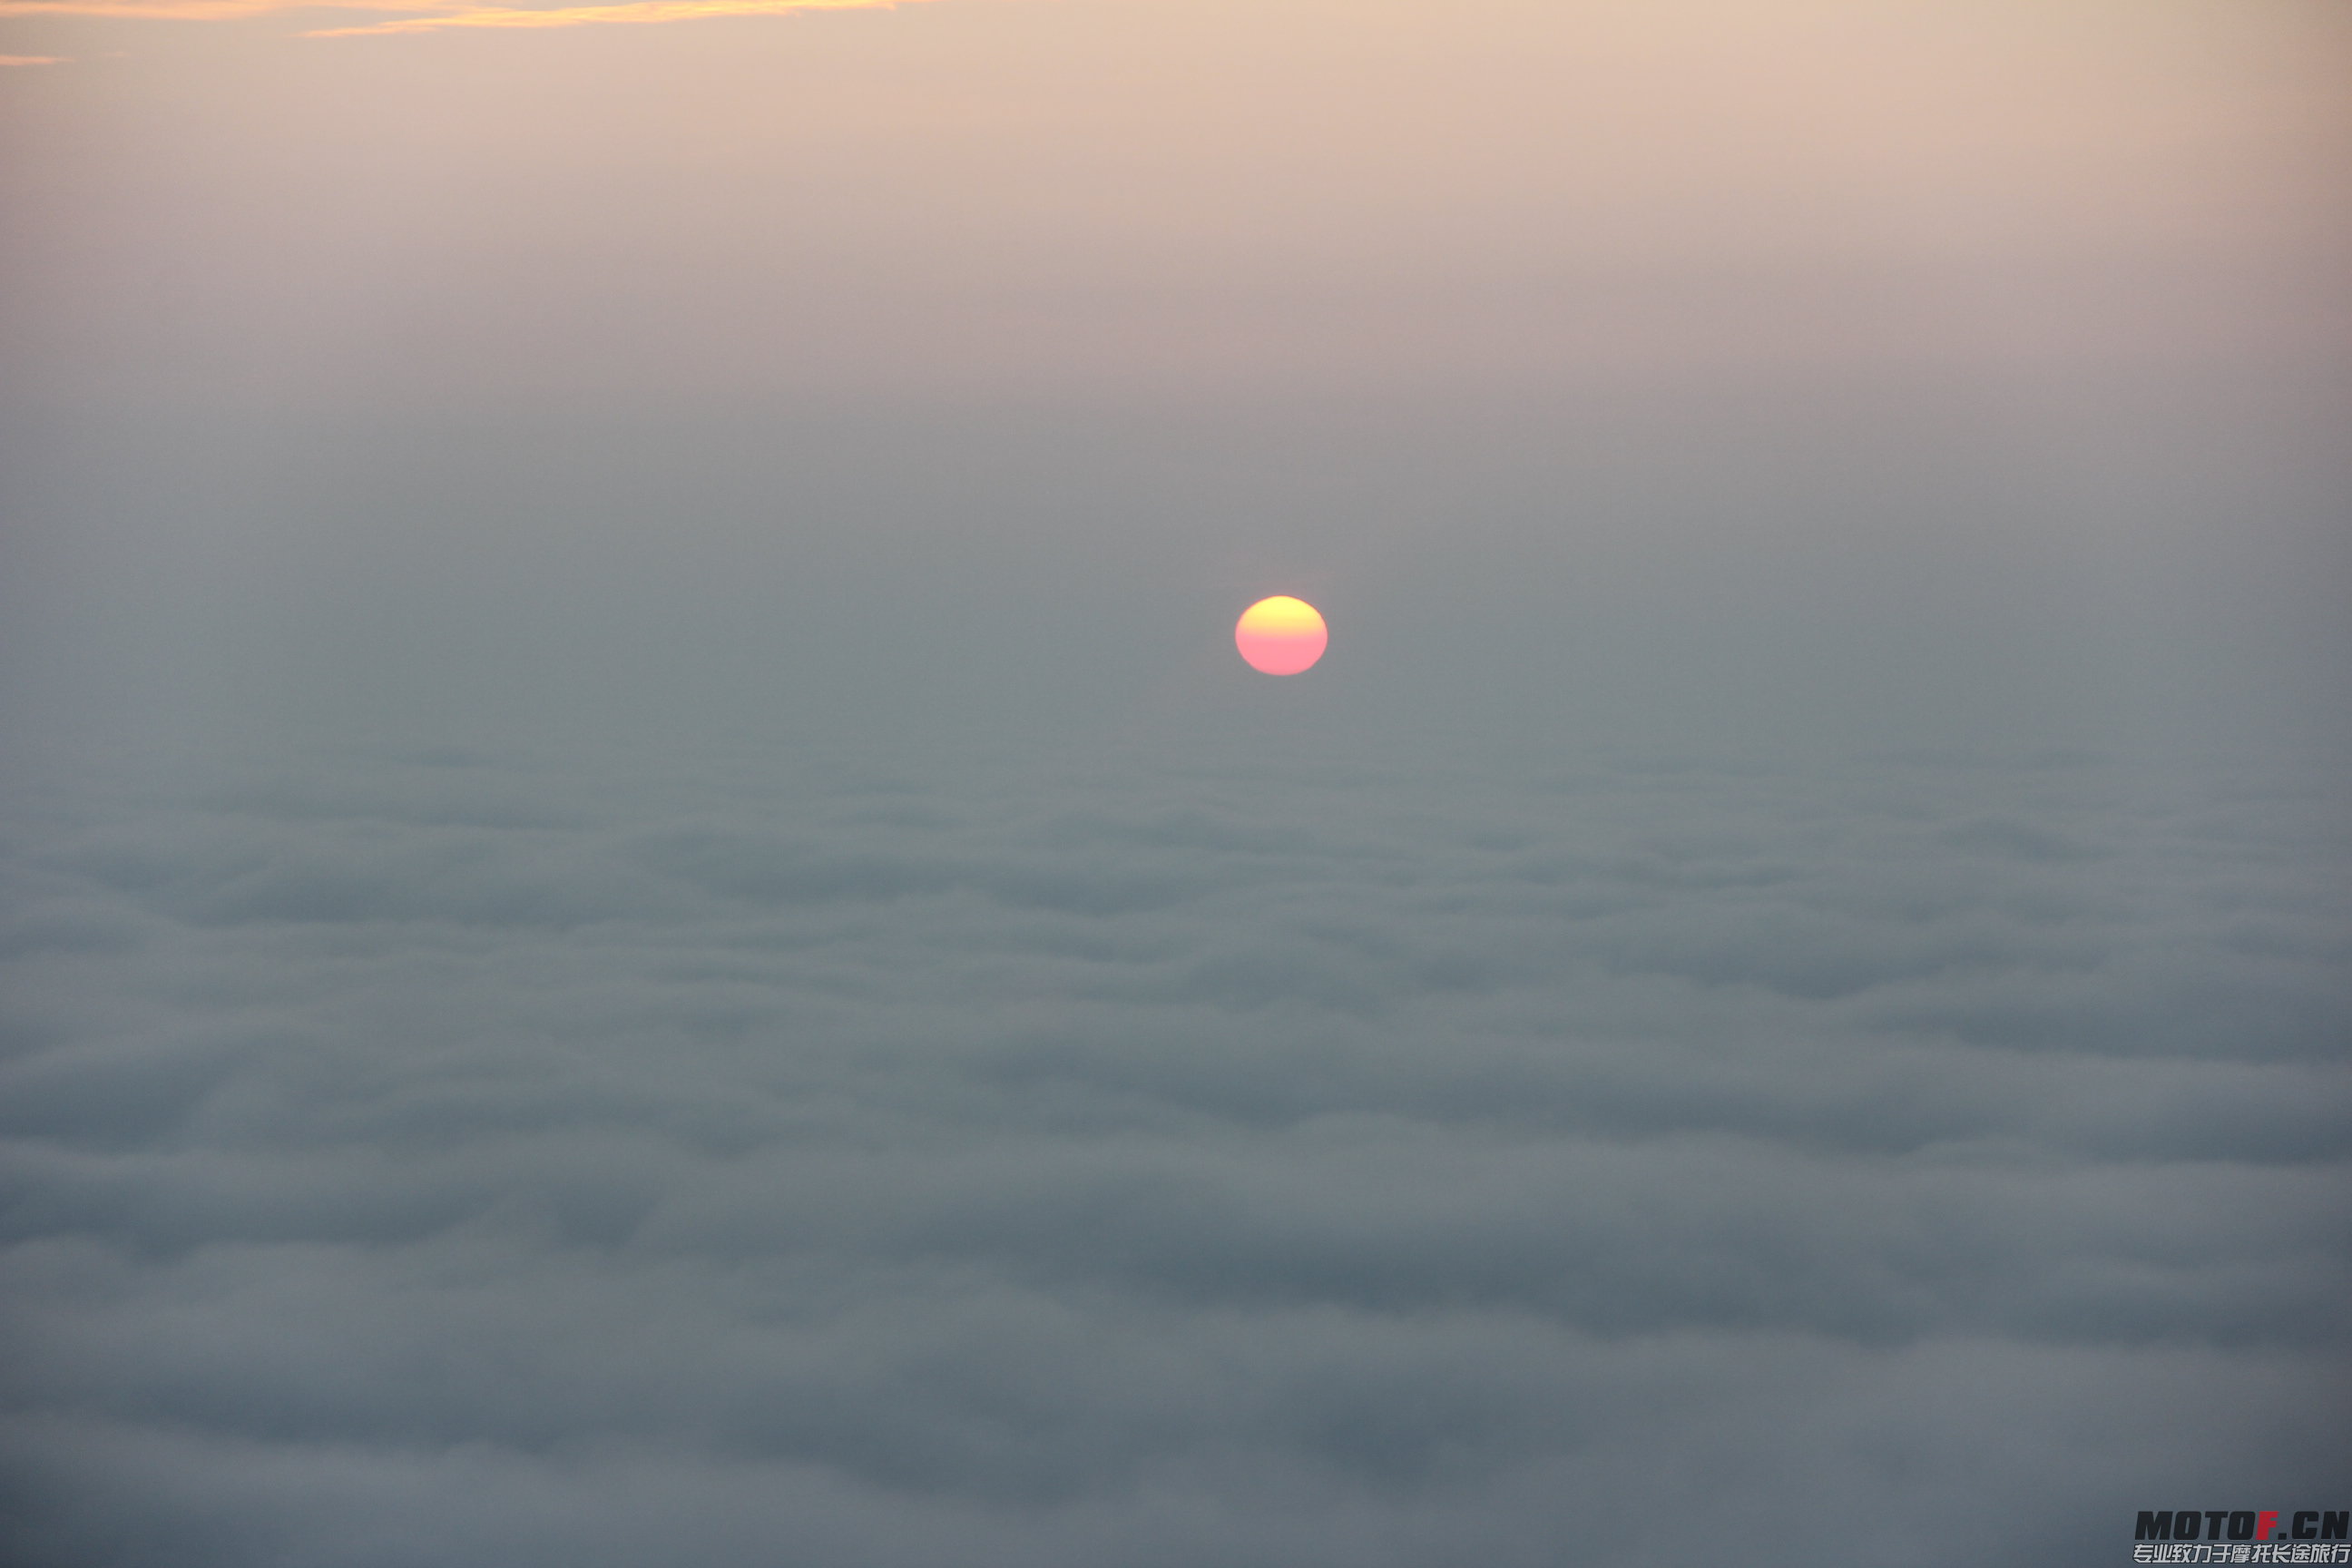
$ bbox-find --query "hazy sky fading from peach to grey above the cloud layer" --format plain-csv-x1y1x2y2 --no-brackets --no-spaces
0,0,2352,761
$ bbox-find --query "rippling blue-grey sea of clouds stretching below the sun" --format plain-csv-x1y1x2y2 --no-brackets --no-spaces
0,719,2352,1568
